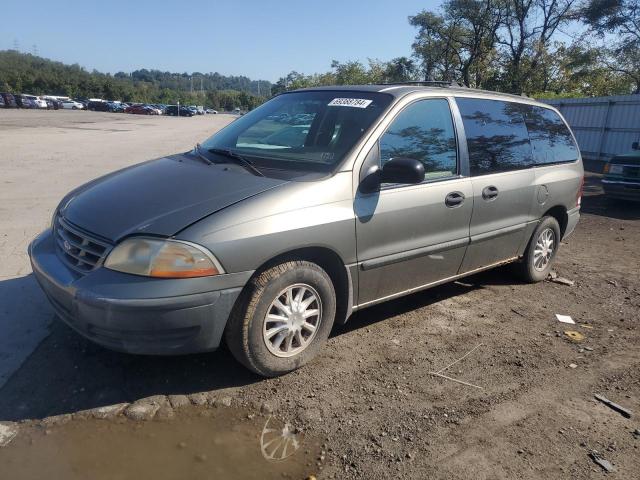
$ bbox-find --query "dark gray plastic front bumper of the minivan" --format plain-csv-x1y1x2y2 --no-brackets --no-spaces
29,230,253,355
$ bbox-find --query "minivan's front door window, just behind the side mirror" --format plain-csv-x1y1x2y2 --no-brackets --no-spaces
380,99,457,180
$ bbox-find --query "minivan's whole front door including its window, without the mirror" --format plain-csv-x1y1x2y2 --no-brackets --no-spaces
354,98,473,306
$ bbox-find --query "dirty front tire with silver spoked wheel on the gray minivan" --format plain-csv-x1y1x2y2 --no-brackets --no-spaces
225,260,336,377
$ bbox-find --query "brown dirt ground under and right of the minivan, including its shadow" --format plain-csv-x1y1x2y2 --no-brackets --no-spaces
0,110,640,480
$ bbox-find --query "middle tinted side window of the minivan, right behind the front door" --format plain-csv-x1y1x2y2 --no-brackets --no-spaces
456,98,533,175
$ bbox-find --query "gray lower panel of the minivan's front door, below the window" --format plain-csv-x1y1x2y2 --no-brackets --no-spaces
354,178,473,305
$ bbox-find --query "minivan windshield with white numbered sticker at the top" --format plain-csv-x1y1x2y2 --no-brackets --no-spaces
202,90,392,172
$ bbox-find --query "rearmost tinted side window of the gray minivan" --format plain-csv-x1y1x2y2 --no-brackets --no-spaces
522,105,578,165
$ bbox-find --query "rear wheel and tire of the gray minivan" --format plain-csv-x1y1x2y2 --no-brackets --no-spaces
516,216,561,283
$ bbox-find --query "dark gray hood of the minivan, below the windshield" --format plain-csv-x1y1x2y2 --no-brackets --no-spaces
60,155,287,242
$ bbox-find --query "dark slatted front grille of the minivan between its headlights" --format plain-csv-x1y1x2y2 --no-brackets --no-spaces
55,216,111,273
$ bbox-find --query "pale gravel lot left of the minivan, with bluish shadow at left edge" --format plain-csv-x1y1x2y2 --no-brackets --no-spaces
0,109,234,387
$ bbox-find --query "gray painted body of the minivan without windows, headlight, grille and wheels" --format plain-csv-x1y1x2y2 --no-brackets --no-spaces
29,86,583,353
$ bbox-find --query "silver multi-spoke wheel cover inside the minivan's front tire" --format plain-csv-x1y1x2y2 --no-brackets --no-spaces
262,283,322,357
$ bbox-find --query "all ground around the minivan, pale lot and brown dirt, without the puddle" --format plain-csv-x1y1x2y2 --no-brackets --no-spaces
0,111,640,479
